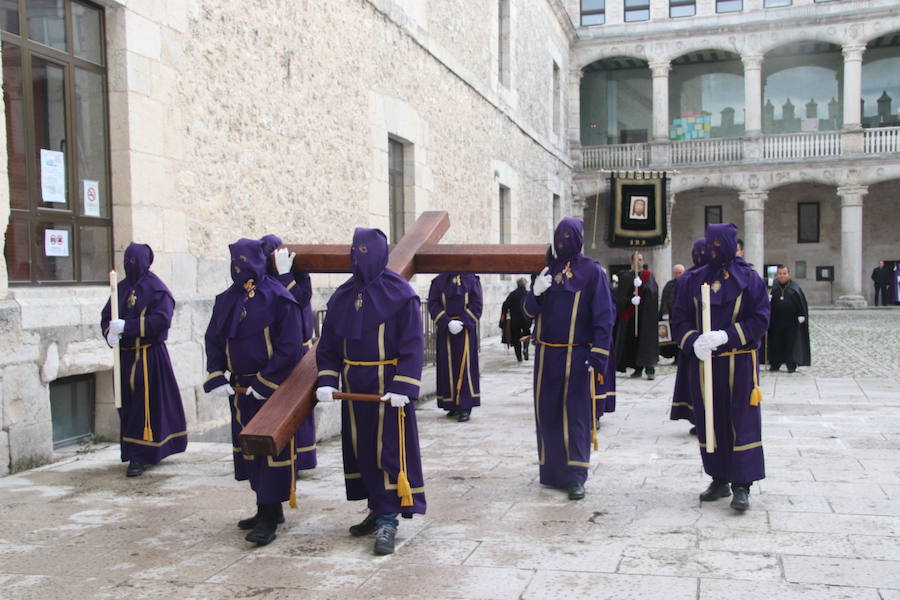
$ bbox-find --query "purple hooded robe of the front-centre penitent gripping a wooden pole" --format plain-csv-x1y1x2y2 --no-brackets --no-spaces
316,227,425,517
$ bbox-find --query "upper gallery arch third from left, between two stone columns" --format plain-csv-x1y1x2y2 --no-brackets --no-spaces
762,41,844,133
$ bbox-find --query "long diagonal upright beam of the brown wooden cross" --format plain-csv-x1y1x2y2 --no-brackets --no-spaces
241,211,450,456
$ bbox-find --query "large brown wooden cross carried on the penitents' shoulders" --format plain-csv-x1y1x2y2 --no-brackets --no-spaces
241,211,547,456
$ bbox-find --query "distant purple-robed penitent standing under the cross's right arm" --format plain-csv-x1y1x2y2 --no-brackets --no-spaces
428,273,483,410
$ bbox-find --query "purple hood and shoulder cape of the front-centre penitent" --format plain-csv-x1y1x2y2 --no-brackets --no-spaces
328,227,416,340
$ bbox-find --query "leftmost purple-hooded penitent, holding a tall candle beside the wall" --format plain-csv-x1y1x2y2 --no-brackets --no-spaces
101,243,187,464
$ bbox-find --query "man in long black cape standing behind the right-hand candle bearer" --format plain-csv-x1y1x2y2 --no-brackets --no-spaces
766,265,810,373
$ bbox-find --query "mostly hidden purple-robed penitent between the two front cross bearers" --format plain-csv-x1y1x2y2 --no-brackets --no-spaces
259,234,317,471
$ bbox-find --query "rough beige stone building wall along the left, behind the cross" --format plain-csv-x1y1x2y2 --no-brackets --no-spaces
0,0,574,473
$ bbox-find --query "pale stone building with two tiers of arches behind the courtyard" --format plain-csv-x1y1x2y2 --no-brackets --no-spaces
567,0,900,306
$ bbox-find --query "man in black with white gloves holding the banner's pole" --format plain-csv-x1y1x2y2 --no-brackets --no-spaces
615,252,659,379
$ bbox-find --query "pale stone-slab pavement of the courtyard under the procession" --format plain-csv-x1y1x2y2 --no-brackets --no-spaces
0,310,900,600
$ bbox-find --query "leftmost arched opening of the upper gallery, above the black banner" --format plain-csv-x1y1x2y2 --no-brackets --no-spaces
581,57,653,146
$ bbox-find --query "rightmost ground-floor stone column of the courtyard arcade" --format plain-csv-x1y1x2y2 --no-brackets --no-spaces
836,185,869,308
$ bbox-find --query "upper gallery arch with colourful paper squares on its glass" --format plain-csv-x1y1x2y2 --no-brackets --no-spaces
669,50,744,140
